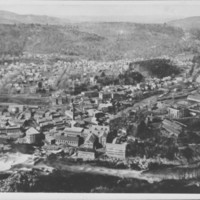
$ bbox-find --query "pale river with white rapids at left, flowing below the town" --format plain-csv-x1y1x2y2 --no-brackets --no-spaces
0,149,200,188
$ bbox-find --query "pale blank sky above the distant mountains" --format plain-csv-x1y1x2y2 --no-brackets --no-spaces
0,0,200,21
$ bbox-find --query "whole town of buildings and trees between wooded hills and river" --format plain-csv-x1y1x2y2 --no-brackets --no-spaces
0,52,200,170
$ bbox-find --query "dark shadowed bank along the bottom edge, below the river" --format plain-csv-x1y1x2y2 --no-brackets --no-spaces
0,170,200,193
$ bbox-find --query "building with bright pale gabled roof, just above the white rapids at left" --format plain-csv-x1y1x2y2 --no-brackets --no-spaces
26,127,41,144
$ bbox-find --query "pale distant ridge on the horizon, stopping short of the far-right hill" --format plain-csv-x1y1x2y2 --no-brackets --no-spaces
0,10,181,25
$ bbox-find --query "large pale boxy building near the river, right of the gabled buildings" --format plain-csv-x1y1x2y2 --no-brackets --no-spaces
106,143,127,159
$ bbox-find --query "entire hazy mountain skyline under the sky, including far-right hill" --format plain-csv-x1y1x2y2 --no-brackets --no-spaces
0,10,200,30
